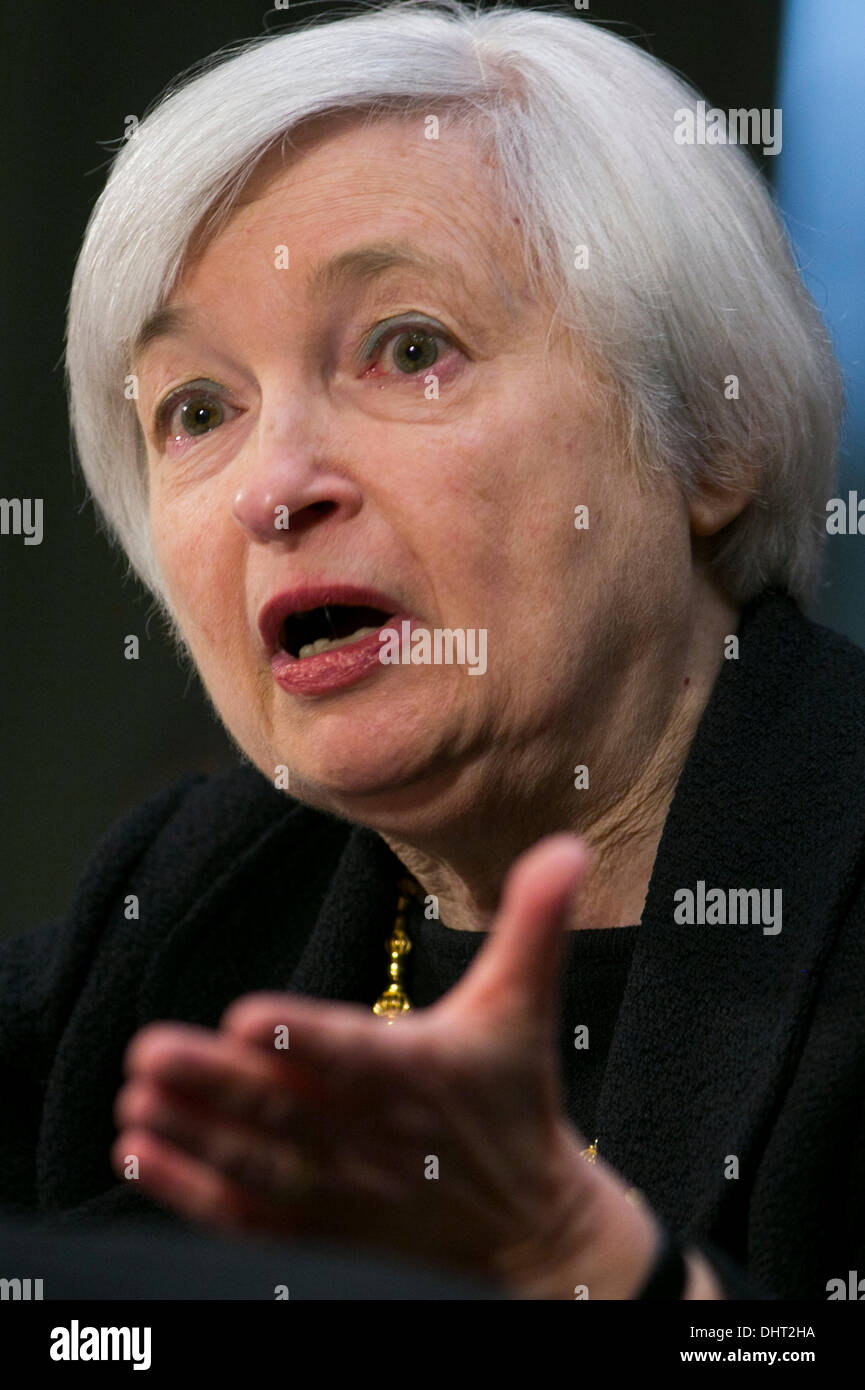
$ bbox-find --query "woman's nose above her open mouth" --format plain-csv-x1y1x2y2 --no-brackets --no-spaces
232,413,362,542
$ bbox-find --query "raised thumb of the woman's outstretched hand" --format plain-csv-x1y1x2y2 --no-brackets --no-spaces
442,835,590,1029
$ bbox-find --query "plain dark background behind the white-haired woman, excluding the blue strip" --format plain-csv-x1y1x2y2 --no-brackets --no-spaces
0,0,801,933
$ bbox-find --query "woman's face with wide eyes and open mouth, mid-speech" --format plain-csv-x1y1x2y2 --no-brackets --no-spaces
136,118,691,823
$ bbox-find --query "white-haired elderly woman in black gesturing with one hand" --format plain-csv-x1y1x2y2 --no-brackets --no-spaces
1,3,865,1300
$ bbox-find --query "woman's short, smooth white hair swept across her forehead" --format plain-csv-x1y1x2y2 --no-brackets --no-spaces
67,0,843,616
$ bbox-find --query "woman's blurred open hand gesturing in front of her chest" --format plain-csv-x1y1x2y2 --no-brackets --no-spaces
113,835,656,1298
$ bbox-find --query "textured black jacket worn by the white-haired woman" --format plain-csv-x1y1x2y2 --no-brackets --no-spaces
0,591,865,1300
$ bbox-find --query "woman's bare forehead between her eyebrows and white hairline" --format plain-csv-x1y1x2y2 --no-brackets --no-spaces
185,113,527,311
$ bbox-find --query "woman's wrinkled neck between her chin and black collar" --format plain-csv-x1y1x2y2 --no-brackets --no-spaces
380,589,738,931
